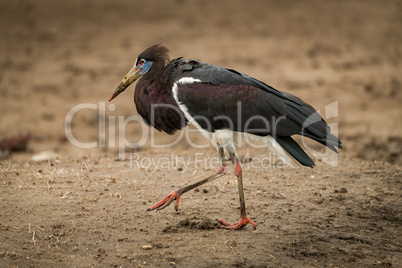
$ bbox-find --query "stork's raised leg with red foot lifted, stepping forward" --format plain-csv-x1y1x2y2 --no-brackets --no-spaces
147,143,227,211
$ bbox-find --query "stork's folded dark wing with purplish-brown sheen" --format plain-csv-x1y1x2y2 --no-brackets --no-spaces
170,60,341,155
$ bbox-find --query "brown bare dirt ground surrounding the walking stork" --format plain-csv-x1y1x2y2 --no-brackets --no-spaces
0,0,402,267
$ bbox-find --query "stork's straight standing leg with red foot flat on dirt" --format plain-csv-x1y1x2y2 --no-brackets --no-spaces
218,145,256,230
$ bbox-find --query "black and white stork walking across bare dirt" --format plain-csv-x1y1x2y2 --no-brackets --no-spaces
109,44,342,229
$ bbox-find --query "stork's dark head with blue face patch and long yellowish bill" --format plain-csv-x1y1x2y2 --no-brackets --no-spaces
109,44,169,101
